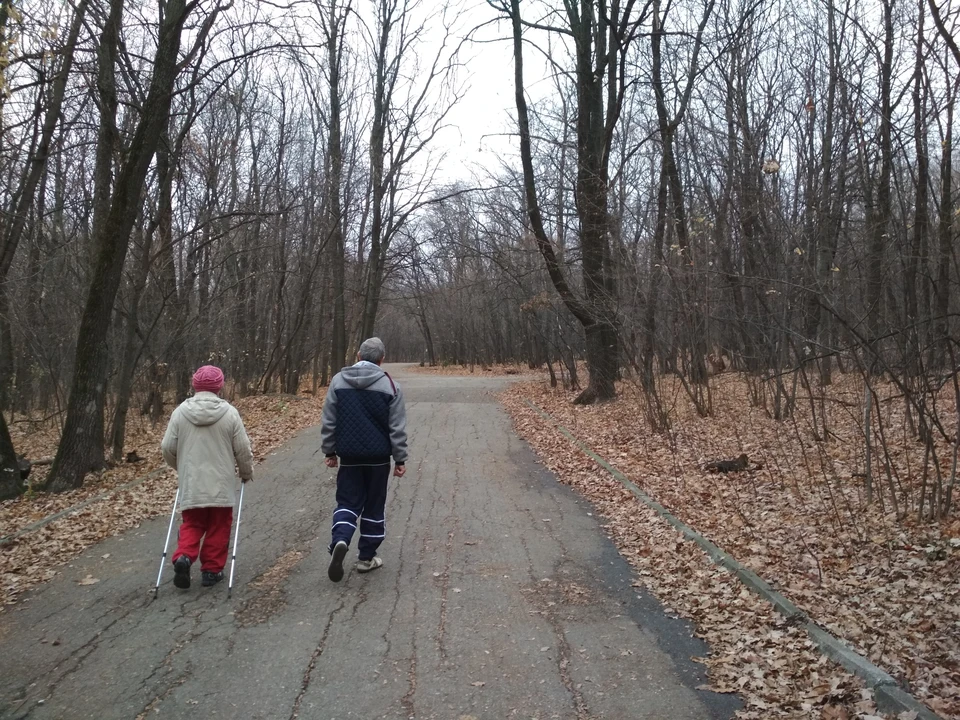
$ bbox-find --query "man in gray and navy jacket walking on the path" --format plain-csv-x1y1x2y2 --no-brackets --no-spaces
321,338,407,582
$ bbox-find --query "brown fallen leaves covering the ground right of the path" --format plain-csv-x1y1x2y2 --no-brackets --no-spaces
501,374,960,719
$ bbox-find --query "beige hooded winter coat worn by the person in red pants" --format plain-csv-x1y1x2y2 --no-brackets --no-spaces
160,392,253,510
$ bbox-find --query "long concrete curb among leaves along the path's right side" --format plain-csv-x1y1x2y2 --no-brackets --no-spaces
524,400,942,720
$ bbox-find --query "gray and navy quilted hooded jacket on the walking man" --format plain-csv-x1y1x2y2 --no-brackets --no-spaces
321,360,407,465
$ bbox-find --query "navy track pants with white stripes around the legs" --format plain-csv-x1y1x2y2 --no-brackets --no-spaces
330,463,390,560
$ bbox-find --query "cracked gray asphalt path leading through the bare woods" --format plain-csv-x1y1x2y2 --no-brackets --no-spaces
0,366,738,720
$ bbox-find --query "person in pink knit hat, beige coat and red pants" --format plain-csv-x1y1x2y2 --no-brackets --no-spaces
158,365,253,590
